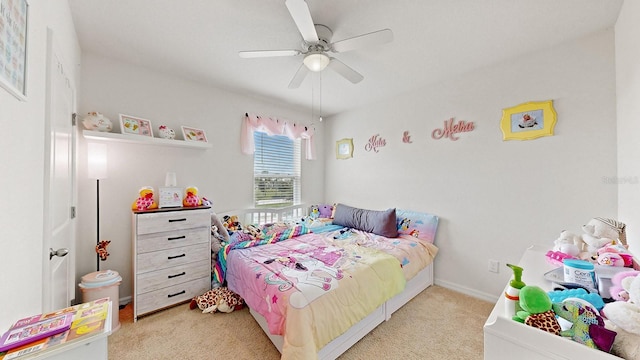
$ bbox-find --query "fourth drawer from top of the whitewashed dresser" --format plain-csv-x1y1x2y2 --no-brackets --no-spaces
136,260,211,294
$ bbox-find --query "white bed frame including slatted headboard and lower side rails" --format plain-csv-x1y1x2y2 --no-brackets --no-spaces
220,204,433,360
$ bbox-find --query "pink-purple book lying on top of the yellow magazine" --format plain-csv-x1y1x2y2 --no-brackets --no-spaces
0,313,73,352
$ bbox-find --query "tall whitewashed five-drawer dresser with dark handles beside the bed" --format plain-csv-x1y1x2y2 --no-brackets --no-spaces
132,207,211,321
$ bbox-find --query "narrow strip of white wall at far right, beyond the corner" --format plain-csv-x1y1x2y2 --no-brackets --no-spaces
616,1,640,254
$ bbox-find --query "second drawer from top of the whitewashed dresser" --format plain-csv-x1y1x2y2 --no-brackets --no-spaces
136,227,211,254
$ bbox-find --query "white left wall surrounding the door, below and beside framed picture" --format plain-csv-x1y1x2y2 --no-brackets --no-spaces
0,0,80,329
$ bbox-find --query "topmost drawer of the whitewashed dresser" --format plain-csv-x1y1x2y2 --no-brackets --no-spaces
136,209,211,236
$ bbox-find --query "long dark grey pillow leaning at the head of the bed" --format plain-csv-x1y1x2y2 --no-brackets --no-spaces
333,204,398,238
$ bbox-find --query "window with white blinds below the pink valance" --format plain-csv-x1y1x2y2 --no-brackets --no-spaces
253,131,300,208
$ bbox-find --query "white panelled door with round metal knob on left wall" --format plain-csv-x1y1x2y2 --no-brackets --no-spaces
42,29,75,311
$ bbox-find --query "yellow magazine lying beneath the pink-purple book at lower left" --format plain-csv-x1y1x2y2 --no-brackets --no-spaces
0,298,111,360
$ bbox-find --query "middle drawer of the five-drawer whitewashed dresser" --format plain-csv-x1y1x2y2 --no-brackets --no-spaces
136,243,211,275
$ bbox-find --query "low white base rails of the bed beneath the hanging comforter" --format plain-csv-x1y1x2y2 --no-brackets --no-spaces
249,262,433,360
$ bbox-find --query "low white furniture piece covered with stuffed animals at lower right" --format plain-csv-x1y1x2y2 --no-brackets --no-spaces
484,245,620,360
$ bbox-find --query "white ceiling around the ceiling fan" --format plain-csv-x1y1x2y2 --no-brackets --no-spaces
69,0,623,116
